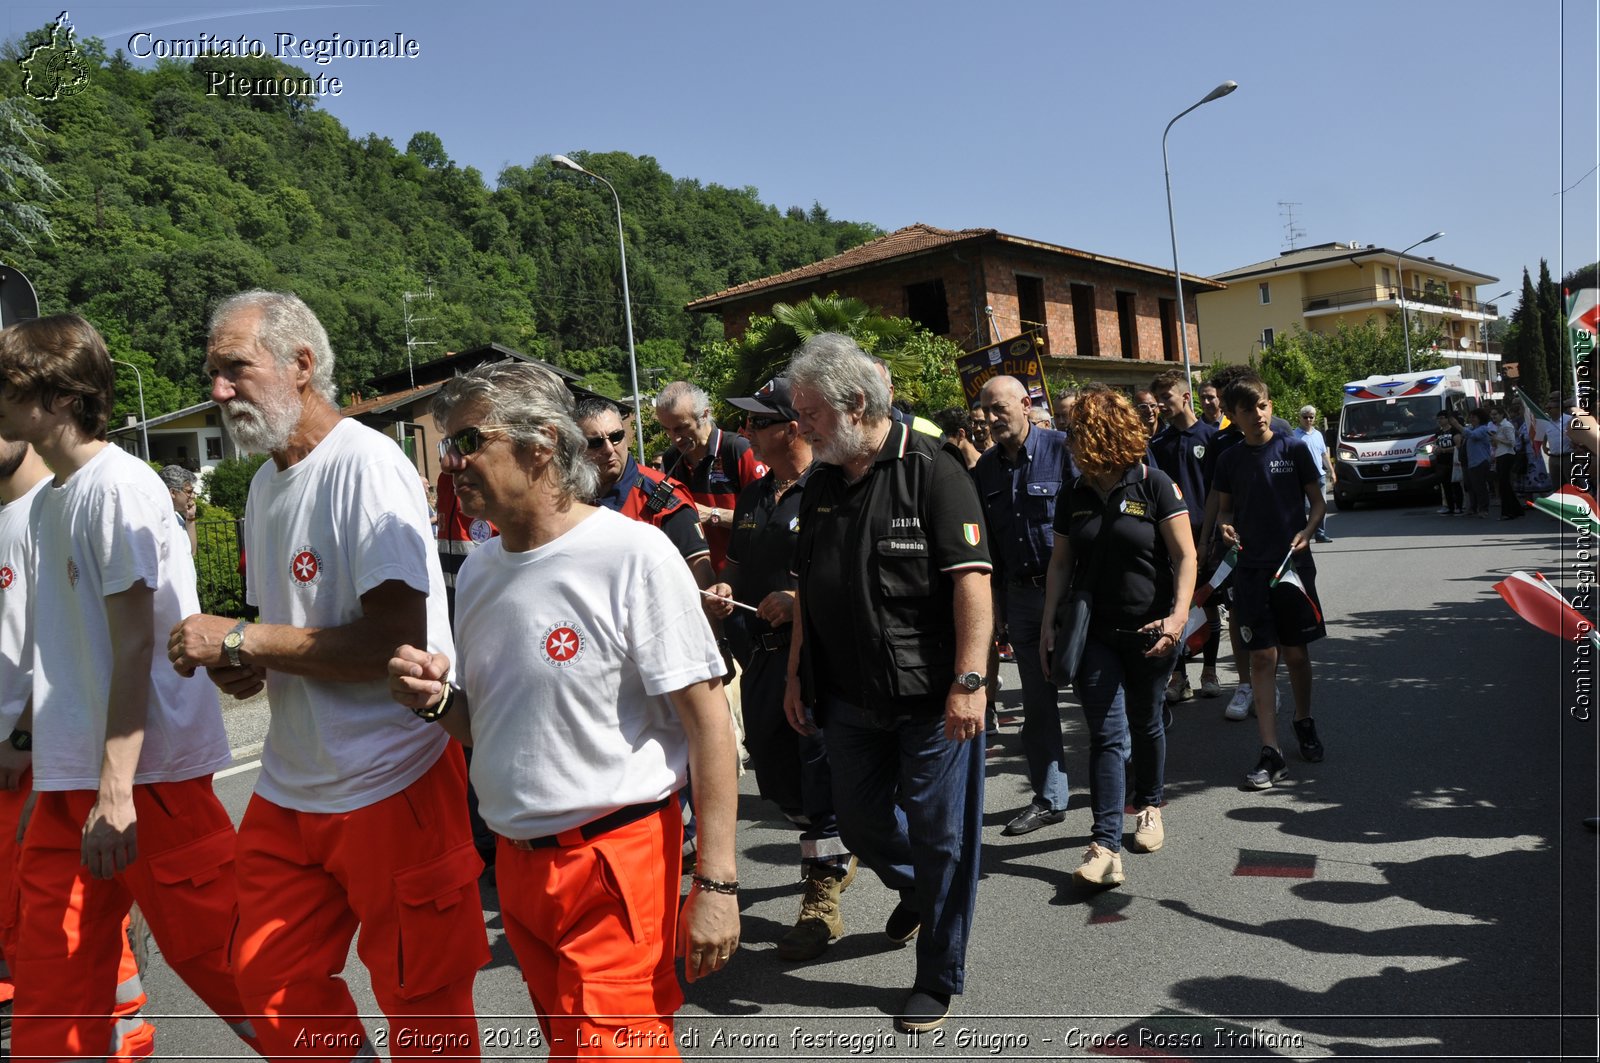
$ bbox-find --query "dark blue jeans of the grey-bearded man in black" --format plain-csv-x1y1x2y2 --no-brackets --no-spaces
818,696,984,994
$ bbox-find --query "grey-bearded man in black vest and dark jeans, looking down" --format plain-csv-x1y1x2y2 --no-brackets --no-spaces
784,333,994,1033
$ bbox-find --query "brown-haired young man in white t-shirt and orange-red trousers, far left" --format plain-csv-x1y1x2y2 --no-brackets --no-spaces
0,314,256,1060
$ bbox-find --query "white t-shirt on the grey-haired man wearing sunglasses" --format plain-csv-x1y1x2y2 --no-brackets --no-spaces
453,509,723,839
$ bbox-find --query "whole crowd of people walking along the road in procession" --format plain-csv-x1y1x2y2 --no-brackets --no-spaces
0,291,1568,1060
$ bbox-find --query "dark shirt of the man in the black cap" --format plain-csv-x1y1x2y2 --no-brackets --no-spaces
723,469,811,660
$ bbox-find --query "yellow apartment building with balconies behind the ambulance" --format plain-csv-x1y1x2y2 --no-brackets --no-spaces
1197,242,1499,383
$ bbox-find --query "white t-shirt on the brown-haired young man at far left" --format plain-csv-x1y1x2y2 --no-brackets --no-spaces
30,445,230,789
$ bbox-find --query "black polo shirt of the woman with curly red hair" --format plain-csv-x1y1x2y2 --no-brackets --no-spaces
1056,464,1189,631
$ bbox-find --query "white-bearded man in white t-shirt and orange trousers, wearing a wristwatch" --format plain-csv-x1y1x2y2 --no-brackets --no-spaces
168,291,488,1060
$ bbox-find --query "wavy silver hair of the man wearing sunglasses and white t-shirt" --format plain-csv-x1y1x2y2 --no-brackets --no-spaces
432,362,600,501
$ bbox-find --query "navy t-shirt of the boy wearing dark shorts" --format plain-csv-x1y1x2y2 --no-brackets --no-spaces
1213,432,1317,570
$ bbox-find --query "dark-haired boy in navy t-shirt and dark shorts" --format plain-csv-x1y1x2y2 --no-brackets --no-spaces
1213,376,1328,789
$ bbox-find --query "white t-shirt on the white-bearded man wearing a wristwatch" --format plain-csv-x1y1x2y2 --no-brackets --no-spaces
245,419,454,812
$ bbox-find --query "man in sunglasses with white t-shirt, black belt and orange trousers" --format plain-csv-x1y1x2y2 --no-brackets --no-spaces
389,362,739,1058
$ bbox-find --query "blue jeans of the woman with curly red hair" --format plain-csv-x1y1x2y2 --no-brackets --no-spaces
1074,628,1174,852
